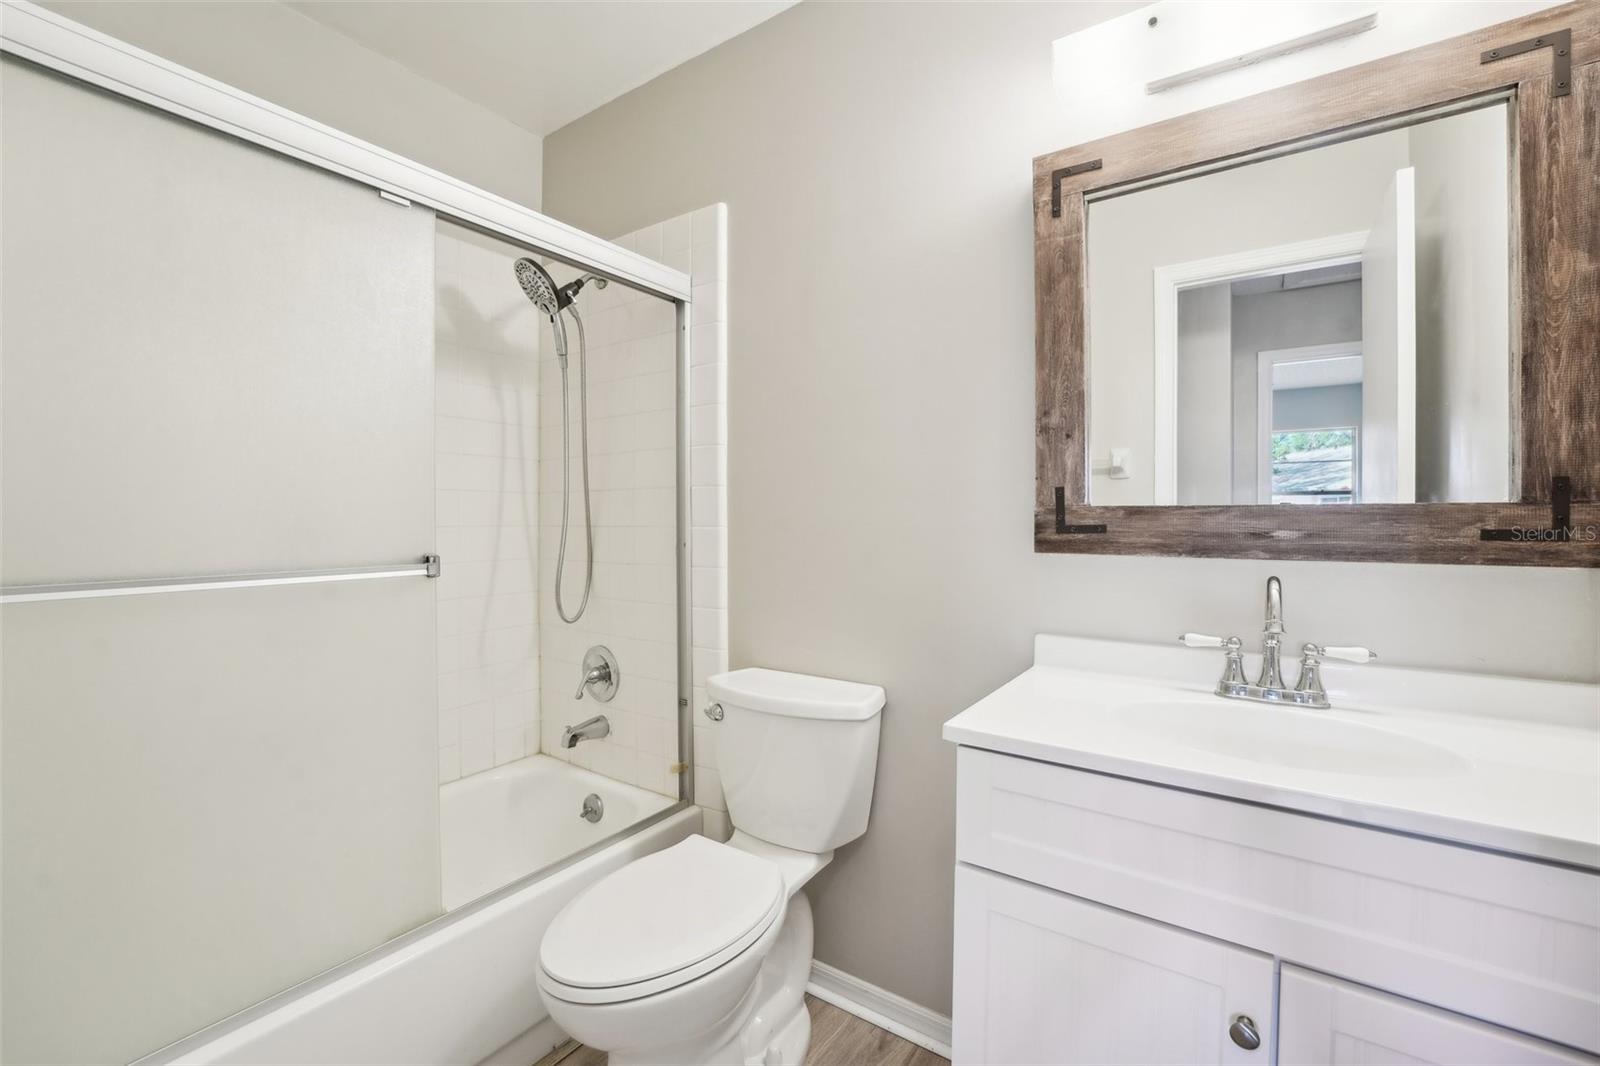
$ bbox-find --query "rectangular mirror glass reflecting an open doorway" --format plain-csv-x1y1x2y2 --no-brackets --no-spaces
1086,99,1515,506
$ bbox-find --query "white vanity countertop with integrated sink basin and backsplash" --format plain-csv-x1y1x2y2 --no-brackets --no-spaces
944,637,1600,869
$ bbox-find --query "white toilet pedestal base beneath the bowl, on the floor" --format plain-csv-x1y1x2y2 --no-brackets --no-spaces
604,892,813,1066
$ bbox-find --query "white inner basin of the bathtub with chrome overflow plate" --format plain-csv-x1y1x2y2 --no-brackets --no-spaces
438,755,675,911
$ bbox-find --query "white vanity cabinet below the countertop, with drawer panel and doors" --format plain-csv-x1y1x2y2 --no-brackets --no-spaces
954,746,1600,1066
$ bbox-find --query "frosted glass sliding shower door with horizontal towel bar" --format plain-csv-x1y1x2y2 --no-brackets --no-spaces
0,58,448,1063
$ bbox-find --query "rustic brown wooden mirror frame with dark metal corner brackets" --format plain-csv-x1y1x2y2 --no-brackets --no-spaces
1034,0,1600,567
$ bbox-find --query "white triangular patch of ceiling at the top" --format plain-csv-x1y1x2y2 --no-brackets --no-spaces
288,0,795,136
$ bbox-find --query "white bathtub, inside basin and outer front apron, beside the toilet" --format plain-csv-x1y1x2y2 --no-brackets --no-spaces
139,755,701,1066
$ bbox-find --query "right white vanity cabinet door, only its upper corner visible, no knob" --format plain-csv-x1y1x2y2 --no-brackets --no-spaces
1278,965,1600,1066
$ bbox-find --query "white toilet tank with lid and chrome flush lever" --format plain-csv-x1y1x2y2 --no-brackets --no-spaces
706,669,883,853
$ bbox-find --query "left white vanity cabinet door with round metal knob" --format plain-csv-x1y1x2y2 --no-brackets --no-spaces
954,864,1274,1066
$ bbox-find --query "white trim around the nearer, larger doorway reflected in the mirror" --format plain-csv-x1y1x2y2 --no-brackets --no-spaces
1150,229,1366,504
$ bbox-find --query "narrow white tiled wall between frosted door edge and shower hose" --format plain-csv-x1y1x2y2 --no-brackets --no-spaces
434,222,539,783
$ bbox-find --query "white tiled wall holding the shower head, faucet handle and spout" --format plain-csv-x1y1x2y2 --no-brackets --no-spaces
539,205,728,809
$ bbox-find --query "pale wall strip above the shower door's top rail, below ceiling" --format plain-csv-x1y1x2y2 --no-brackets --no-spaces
43,0,541,208
